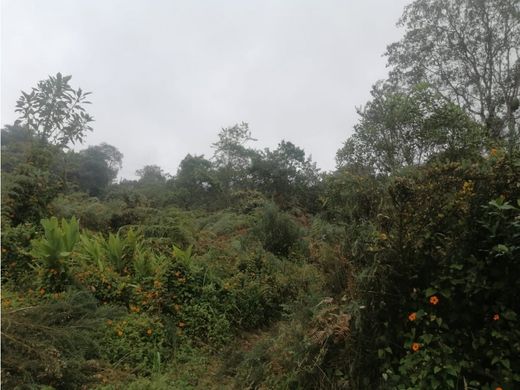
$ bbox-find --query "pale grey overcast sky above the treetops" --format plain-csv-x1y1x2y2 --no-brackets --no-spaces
0,0,409,178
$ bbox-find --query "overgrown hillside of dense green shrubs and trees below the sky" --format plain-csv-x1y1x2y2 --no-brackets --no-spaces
1,0,520,390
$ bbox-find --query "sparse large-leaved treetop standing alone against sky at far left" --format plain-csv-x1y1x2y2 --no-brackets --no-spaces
15,73,94,148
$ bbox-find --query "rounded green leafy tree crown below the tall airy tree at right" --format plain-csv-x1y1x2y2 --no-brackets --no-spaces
337,83,483,174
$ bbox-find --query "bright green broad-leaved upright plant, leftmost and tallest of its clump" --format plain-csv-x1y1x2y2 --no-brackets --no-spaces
31,217,79,292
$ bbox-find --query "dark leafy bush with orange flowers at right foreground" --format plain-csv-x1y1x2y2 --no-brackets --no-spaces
345,153,520,389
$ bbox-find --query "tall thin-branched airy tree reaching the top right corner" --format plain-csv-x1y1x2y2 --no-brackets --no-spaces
387,0,520,140
